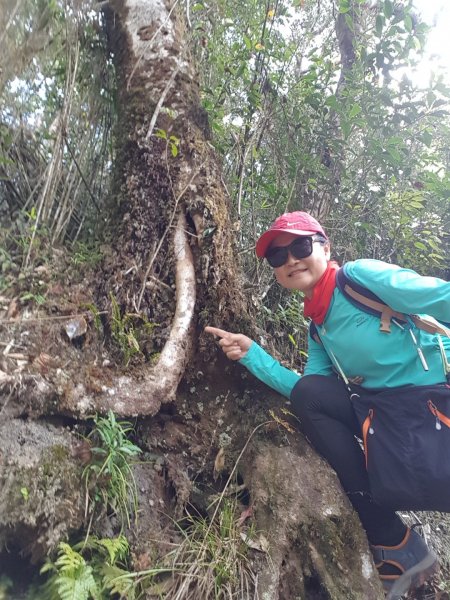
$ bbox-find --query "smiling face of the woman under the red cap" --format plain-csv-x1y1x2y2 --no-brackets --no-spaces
270,233,330,298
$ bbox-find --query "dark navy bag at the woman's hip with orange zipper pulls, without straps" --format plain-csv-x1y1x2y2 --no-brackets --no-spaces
351,384,450,512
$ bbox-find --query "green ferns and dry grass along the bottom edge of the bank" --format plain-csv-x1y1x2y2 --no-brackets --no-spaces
33,499,256,600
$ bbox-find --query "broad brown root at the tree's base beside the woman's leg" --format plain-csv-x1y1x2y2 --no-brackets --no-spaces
241,436,383,600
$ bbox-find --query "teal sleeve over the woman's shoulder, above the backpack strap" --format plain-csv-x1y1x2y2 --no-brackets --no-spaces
345,259,450,323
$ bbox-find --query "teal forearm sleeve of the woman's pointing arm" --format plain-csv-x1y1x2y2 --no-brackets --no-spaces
239,342,300,398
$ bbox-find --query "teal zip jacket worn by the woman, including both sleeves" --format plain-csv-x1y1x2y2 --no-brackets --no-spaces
239,259,450,398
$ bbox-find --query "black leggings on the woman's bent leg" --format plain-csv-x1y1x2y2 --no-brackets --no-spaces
291,375,406,546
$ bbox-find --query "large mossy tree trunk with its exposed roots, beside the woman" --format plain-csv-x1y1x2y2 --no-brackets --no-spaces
0,0,382,600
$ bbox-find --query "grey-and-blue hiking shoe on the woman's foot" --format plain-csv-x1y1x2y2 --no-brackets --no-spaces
370,527,438,600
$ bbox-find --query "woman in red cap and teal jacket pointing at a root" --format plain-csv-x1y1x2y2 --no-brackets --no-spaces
205,212,450,600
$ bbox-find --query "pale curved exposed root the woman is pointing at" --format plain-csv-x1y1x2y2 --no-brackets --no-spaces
0,213,196,418
